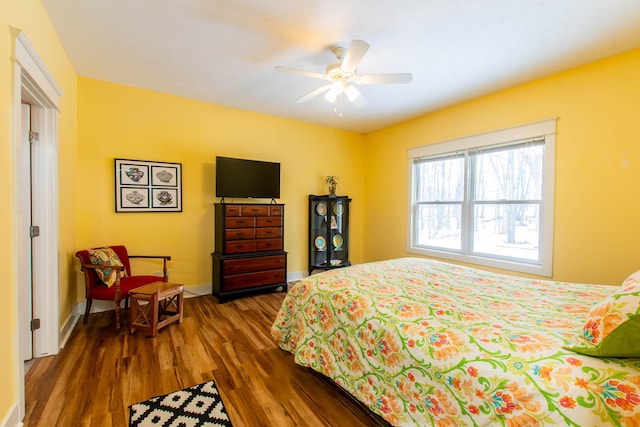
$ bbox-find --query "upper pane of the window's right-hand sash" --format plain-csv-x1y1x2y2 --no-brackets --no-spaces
473,144,544,201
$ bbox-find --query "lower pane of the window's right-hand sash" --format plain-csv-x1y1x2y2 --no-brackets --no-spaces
473,203,540,261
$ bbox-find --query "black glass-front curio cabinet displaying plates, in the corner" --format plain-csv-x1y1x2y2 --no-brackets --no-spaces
309,196,350,273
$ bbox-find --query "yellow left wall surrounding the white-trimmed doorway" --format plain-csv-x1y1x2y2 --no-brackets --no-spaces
0,0,77,422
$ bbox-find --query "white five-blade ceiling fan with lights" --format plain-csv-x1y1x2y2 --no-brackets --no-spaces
275,40,413,107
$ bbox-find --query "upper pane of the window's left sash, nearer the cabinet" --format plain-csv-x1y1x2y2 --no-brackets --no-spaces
414,154,464,202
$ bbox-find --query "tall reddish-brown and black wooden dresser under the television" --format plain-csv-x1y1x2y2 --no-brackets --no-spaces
212,203,287,303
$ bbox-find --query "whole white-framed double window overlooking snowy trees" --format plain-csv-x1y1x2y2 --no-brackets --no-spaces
408,119,555,276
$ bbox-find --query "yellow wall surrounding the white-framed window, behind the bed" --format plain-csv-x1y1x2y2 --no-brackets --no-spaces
364,50,640,284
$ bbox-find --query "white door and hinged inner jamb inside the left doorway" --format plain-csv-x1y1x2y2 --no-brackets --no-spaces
16,97,60,360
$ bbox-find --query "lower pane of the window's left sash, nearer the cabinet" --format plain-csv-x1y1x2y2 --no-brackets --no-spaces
415,204,462,250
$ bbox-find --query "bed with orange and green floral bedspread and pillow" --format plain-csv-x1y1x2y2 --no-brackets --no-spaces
271,258,640,427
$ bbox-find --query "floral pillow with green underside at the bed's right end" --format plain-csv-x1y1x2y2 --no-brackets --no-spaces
569,270,640,357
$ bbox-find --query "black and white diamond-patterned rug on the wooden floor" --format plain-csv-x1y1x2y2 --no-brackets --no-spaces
129,381,231,427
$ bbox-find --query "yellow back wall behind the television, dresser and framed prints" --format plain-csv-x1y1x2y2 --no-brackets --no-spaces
76,78,364,290
